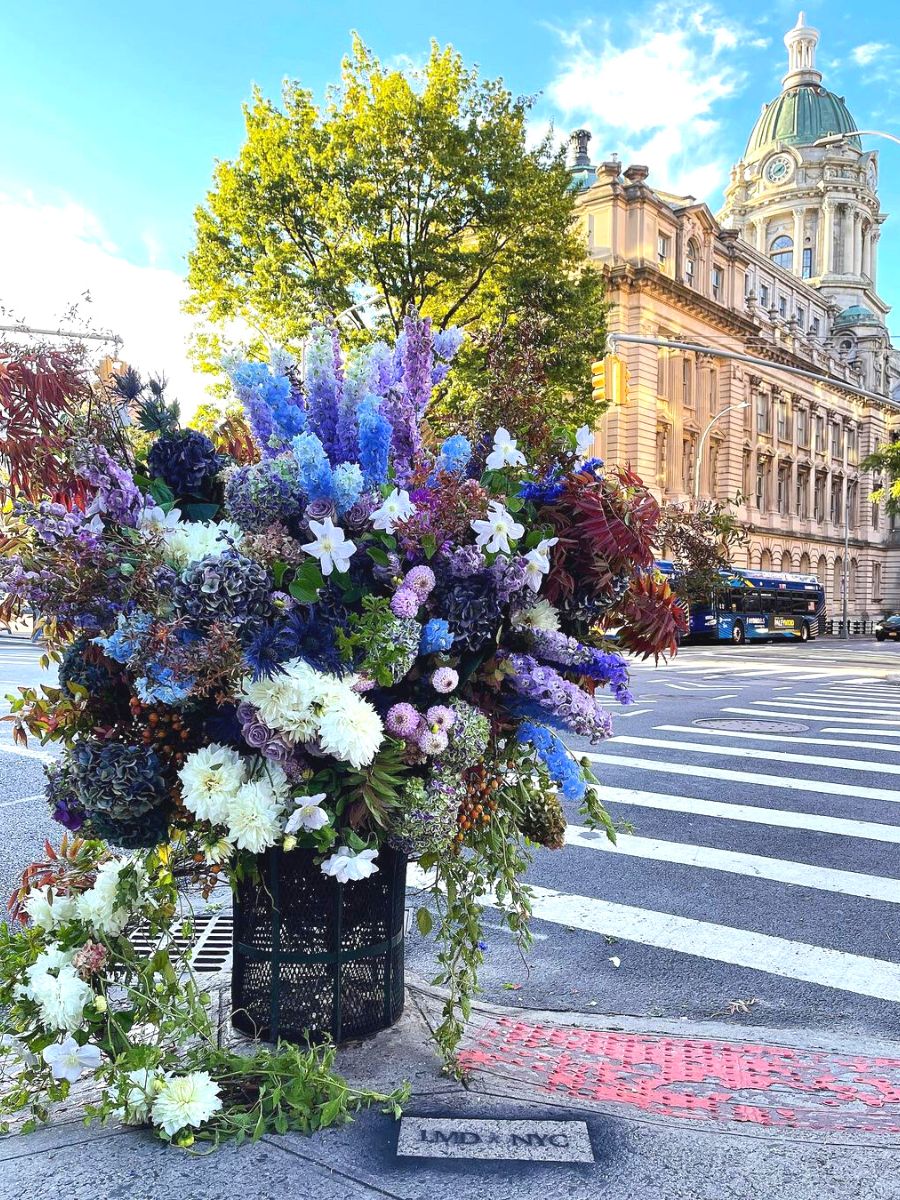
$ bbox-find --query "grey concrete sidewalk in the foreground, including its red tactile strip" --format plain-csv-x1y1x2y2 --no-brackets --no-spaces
0,983,900,1200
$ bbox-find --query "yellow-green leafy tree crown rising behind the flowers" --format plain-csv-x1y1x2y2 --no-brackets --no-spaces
188,38,602,401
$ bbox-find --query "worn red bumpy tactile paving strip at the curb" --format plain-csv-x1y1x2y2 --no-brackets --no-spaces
460,1016,900,1133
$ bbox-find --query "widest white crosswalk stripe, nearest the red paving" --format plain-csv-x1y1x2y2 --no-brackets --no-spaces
513,887,900,1002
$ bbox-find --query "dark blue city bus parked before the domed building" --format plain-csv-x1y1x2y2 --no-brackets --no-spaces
655,562,826,646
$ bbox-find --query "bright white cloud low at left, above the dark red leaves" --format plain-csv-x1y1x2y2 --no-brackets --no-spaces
0,192,209,414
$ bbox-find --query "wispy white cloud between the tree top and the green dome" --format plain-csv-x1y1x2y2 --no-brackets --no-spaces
546,5,764,198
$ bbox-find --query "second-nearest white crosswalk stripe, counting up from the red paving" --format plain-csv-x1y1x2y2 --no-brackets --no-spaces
565,826,900,904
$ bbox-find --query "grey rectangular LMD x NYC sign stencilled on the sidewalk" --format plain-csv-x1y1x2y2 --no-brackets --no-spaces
397,1117,594,1163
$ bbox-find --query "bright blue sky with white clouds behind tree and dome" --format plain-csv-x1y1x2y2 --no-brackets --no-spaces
0,0,900,398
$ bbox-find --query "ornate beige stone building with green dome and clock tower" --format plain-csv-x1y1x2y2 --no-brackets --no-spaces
572,13,900,620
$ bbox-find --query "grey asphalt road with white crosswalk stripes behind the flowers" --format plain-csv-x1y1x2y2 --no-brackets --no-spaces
0,638,900,1037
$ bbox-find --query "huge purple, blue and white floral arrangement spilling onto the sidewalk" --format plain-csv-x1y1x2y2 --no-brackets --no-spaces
0,313,683,1144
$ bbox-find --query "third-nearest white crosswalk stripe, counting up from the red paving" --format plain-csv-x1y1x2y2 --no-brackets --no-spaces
600,784,900,845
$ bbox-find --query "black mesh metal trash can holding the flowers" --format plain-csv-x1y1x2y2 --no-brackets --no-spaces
232,846,407,1043
